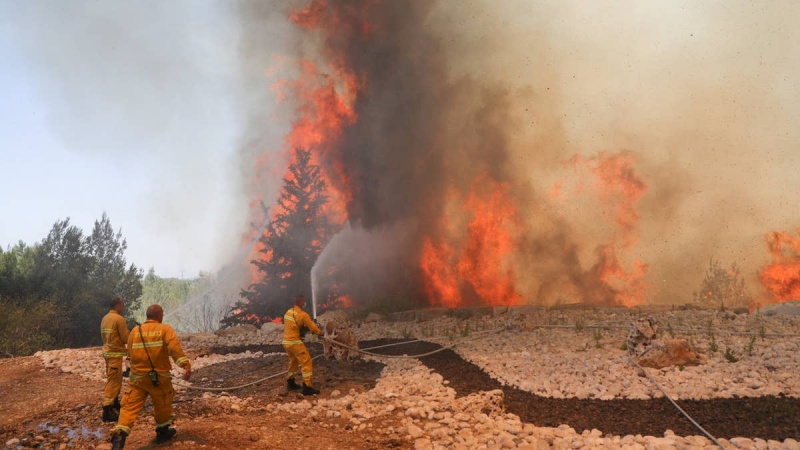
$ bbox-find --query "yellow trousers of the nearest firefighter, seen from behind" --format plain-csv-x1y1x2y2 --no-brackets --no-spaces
111,375,175,434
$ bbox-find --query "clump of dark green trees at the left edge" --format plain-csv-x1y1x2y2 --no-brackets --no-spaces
0,213,142,357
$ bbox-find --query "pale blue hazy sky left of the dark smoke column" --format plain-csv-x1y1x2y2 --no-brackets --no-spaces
0,1,262,278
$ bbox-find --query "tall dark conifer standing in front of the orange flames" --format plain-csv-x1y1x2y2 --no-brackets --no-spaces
223,148,334,325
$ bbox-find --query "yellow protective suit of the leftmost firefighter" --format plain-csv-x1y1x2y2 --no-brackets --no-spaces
100,309,129,406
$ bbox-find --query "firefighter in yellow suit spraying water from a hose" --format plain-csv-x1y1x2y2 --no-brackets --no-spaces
283,295,322,395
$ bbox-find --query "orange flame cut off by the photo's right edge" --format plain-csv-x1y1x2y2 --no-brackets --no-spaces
759,228,800,302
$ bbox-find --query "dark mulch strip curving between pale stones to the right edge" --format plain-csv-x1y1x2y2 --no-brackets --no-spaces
361,339,800,441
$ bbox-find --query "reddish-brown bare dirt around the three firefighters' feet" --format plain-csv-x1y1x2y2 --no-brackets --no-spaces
0,357,411,450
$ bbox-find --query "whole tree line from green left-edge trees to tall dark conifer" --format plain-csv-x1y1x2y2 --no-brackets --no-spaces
0,149,346,357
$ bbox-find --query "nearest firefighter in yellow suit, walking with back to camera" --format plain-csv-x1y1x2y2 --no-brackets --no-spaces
111,305,192,450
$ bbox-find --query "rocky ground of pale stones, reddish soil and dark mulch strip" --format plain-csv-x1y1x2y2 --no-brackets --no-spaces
0,308,800,449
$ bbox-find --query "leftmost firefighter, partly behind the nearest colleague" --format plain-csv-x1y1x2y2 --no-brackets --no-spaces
100,297,128,422
